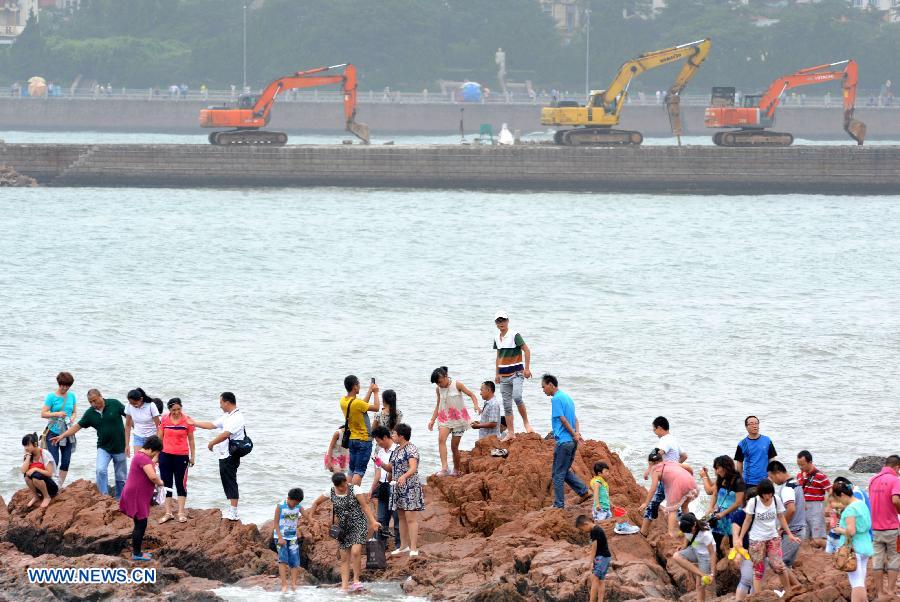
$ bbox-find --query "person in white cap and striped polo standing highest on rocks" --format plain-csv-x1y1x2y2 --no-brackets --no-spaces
494,311,534,439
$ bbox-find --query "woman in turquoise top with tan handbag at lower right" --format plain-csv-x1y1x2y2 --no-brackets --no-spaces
831,479,872,602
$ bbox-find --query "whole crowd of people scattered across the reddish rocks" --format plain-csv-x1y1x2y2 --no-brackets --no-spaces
14,312,900,602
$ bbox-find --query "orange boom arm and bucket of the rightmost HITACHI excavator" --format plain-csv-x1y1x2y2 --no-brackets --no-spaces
759,59,866,144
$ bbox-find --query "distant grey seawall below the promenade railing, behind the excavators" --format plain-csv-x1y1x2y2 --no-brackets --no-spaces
0,97,900,140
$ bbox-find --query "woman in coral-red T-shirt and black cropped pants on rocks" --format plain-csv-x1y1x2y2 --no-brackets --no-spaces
158,397,197,524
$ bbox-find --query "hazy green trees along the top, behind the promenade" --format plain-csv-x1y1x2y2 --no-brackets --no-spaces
0,0,900,93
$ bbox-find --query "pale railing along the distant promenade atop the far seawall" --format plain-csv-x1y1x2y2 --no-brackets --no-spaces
0,87,900,107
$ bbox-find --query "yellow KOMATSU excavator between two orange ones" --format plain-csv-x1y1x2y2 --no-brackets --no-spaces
541,38,712,146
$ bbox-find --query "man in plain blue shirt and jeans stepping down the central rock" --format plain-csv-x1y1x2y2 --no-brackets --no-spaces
541,374,591,508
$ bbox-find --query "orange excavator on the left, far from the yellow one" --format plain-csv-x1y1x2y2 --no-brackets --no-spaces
200,63,369,146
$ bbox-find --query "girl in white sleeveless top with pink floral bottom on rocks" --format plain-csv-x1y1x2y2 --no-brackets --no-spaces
428,366,481,477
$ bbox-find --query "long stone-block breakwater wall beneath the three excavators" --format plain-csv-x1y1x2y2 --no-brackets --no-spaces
0,144,900,195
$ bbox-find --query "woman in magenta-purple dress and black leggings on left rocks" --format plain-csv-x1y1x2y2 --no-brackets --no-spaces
119,435,163,560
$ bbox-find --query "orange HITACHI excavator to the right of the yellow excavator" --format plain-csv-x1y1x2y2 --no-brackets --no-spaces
705,59,866,146
